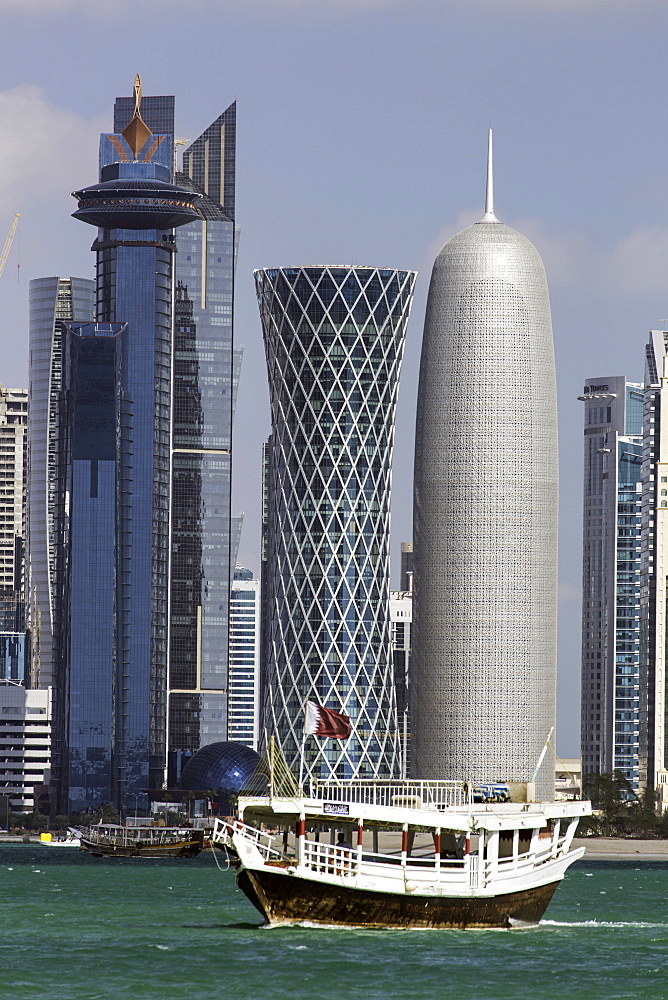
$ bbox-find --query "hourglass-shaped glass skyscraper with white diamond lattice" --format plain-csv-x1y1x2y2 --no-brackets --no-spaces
255,267,415,779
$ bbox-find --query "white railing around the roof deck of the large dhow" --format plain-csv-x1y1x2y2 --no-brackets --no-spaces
310,778,473,812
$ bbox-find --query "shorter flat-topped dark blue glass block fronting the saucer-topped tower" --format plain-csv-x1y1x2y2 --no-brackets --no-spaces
60,323,127,811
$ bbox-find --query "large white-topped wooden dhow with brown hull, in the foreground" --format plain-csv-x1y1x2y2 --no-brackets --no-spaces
212,779,591,929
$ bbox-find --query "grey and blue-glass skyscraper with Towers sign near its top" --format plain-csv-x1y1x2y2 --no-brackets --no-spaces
579,376,643,791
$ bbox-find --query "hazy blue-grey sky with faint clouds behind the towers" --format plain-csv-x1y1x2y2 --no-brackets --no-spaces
0,0,668,756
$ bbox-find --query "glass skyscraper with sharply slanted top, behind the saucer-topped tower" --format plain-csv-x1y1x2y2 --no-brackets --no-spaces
167,98,241,772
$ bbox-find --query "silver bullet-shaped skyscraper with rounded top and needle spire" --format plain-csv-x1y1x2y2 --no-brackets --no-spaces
411,135,558,797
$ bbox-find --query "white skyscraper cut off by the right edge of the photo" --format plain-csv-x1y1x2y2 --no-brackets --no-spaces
638,330,668,811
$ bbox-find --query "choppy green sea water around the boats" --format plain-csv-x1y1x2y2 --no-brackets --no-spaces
0,844,668,1000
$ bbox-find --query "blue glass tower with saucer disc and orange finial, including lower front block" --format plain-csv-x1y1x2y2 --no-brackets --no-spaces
62,80,199,810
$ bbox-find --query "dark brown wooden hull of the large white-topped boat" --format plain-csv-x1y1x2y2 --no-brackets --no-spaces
237,868,560,930
